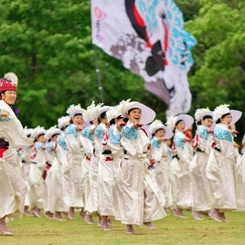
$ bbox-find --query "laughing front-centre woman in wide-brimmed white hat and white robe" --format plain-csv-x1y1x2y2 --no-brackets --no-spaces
116,102,167,234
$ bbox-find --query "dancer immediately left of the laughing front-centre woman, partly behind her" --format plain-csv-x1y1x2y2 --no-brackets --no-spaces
98,107,123,230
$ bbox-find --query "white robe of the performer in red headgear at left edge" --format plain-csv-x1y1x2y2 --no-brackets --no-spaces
0,100,33,219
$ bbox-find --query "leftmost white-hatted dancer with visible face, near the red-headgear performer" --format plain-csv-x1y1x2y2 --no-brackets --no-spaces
28,126,47,218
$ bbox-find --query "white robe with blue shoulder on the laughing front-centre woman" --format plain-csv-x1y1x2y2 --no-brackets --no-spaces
116,121,167,226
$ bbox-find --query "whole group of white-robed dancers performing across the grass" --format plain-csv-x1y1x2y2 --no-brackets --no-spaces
0,72,245,235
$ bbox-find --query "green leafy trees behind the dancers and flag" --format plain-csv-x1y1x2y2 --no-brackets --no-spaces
0,0,245,132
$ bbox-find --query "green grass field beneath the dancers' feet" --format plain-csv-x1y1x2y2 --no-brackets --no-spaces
0,212,245,245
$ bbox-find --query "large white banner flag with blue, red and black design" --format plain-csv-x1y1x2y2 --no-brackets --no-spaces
91,0,196,115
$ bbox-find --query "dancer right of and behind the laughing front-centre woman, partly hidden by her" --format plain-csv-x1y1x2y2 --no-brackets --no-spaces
149,120,173,210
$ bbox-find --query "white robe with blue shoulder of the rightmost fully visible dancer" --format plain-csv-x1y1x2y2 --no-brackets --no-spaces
207,124,237,211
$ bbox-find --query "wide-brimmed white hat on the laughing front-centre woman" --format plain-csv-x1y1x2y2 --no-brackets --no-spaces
119,100,156,124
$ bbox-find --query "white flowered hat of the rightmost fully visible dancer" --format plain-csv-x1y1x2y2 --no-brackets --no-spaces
213,104,242,125
